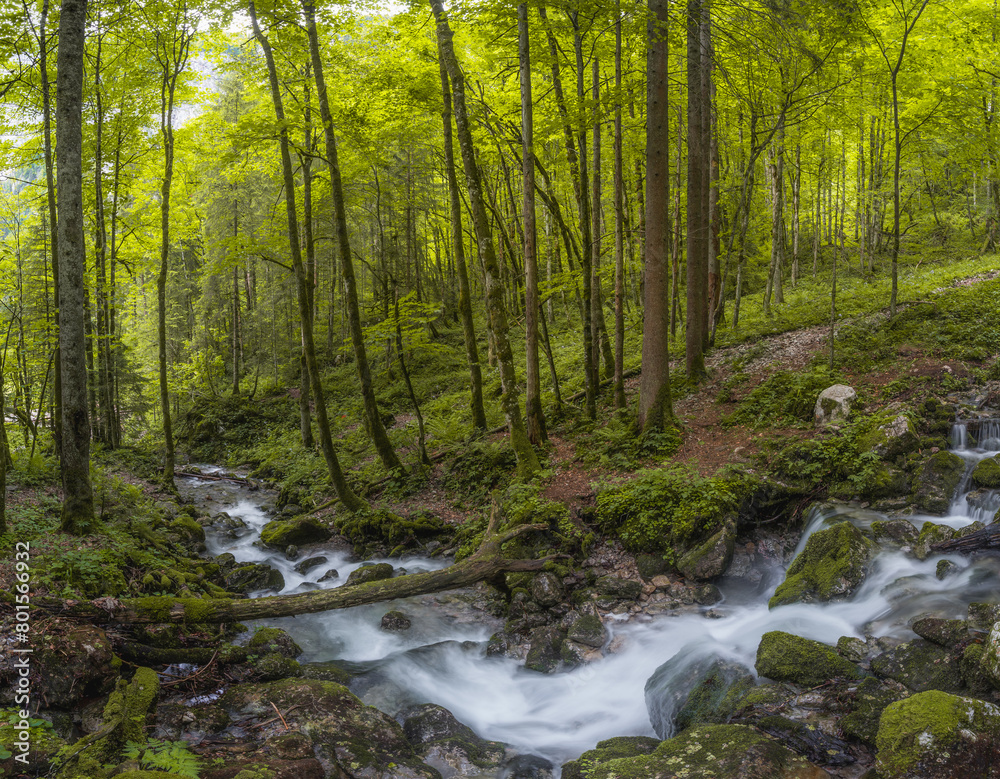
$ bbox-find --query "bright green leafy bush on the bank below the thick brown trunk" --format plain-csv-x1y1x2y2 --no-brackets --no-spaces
597,465,744,552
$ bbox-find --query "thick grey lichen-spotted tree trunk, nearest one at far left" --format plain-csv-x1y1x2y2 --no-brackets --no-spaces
56,0,94,535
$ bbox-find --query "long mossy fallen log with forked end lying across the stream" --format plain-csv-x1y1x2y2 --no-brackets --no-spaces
34,510,564,625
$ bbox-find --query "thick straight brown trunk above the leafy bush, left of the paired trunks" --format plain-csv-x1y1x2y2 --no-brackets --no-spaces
639,0,674,432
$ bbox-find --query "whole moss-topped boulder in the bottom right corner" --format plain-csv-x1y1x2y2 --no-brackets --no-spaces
875,690,1000,779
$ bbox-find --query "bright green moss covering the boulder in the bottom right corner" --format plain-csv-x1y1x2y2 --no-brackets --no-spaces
876,690,1000,779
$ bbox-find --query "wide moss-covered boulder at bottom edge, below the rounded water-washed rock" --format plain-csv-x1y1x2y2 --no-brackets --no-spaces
587,725,828,779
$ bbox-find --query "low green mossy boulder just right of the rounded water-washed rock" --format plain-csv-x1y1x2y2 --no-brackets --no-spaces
754,630,865,687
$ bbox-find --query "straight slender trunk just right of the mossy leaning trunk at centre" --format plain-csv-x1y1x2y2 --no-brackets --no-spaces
517,3,548,446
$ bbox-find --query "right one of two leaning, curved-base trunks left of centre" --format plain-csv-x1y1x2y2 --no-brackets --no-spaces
302,0,403,471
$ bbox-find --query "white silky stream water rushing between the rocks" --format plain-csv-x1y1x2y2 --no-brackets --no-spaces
178,420,1000,765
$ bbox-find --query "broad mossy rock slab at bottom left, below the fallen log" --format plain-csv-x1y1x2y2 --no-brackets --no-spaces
220,678,439,779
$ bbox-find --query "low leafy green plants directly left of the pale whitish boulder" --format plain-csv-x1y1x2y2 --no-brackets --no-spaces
722,365,838,428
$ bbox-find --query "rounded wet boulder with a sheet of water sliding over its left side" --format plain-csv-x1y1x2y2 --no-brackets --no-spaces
645,651,755,738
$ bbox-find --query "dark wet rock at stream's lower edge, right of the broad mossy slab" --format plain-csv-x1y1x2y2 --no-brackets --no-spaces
400,703,505,779
